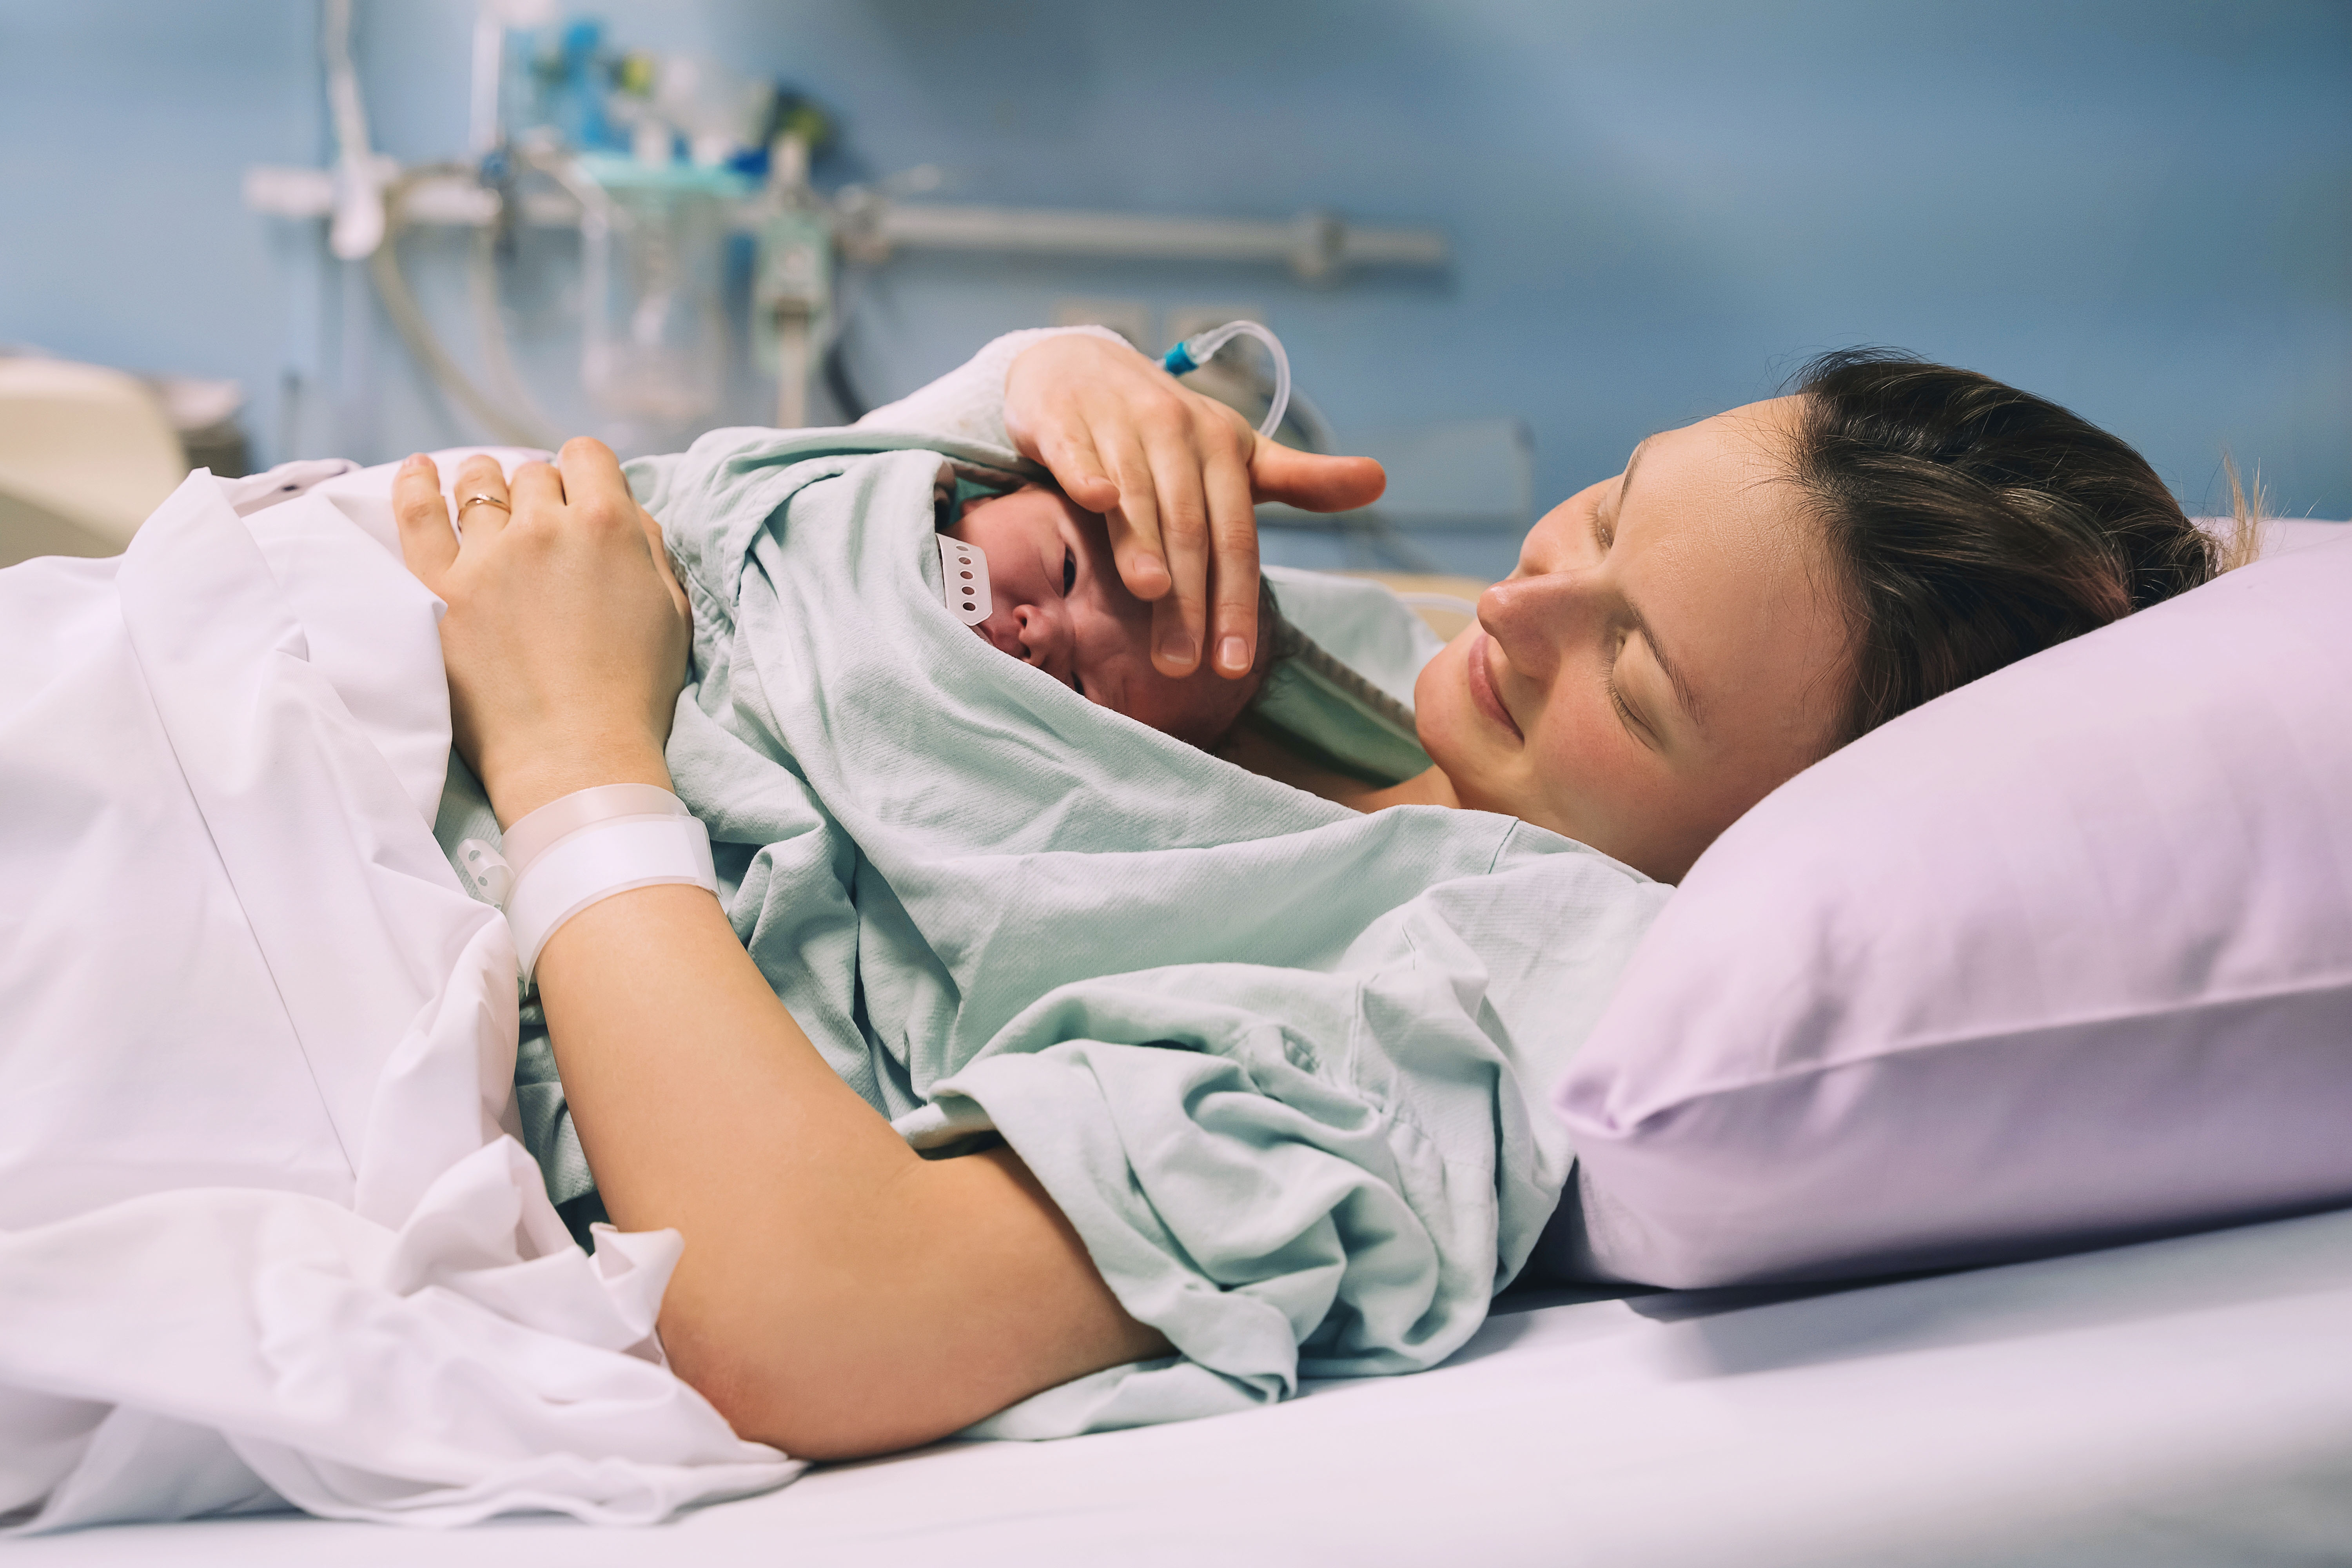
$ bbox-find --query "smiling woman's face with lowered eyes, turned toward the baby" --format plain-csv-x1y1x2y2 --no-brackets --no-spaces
1414,397,1851,882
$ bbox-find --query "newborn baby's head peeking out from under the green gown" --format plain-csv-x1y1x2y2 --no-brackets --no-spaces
948,484,1272,750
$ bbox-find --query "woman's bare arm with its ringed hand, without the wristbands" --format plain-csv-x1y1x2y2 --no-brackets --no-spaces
395,442,1167,1457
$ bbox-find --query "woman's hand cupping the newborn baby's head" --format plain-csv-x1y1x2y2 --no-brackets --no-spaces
1004,334,1388,679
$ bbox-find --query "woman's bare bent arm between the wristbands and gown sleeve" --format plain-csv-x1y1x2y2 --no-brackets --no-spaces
539,886,1167,1457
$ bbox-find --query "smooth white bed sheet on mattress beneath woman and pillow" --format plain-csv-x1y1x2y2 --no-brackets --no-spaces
23,1210,2352,1568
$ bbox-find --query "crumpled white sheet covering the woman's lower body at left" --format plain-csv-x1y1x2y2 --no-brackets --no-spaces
0,470,797,1530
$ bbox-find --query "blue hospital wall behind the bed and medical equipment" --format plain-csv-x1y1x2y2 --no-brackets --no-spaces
0,0,2352,569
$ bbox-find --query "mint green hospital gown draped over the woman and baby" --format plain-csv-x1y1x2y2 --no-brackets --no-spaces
445,430,1665,1436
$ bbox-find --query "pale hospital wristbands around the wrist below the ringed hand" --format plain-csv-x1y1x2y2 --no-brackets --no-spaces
459,785,720,980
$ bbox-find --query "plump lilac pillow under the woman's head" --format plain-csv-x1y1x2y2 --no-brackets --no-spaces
1555,529,2352,1286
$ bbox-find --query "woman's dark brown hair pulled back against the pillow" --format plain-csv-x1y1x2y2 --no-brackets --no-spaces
1792,348,2234,740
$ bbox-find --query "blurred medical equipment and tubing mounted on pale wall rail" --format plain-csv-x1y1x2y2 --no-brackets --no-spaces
245,0,1449,444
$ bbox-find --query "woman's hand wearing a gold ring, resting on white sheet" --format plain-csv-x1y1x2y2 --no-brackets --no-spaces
393,439,689,825
